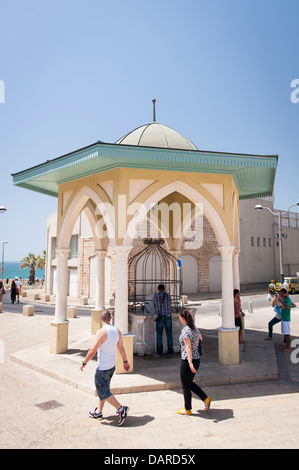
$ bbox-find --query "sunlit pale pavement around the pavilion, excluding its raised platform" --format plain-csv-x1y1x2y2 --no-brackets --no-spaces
0,294,299,450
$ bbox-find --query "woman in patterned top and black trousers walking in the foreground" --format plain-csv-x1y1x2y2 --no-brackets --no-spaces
177,310,211,415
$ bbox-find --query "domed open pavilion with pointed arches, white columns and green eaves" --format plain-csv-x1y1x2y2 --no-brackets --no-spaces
12,100,278,365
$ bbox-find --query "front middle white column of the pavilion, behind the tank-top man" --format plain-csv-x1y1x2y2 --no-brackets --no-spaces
112,245,132,335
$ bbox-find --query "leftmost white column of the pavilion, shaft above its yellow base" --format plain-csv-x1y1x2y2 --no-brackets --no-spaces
54,248,70,323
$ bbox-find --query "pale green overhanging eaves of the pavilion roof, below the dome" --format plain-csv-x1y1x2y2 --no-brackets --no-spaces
12,142,278,198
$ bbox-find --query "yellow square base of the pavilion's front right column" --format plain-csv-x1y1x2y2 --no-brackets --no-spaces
218,327,240,366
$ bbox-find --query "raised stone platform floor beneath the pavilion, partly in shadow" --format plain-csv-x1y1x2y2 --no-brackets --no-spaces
10,330,278,395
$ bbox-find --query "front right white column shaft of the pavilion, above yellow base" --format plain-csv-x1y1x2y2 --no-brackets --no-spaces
218,246,235,329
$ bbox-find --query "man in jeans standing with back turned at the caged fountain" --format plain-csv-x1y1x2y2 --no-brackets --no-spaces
153,284,174,357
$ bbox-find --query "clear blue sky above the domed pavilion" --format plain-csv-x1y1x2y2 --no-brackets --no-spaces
0,0,299,261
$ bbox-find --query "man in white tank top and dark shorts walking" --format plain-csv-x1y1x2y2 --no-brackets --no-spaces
81,310,130,426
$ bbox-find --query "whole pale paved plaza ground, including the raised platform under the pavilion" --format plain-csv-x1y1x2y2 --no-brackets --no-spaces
0,294,299,451
